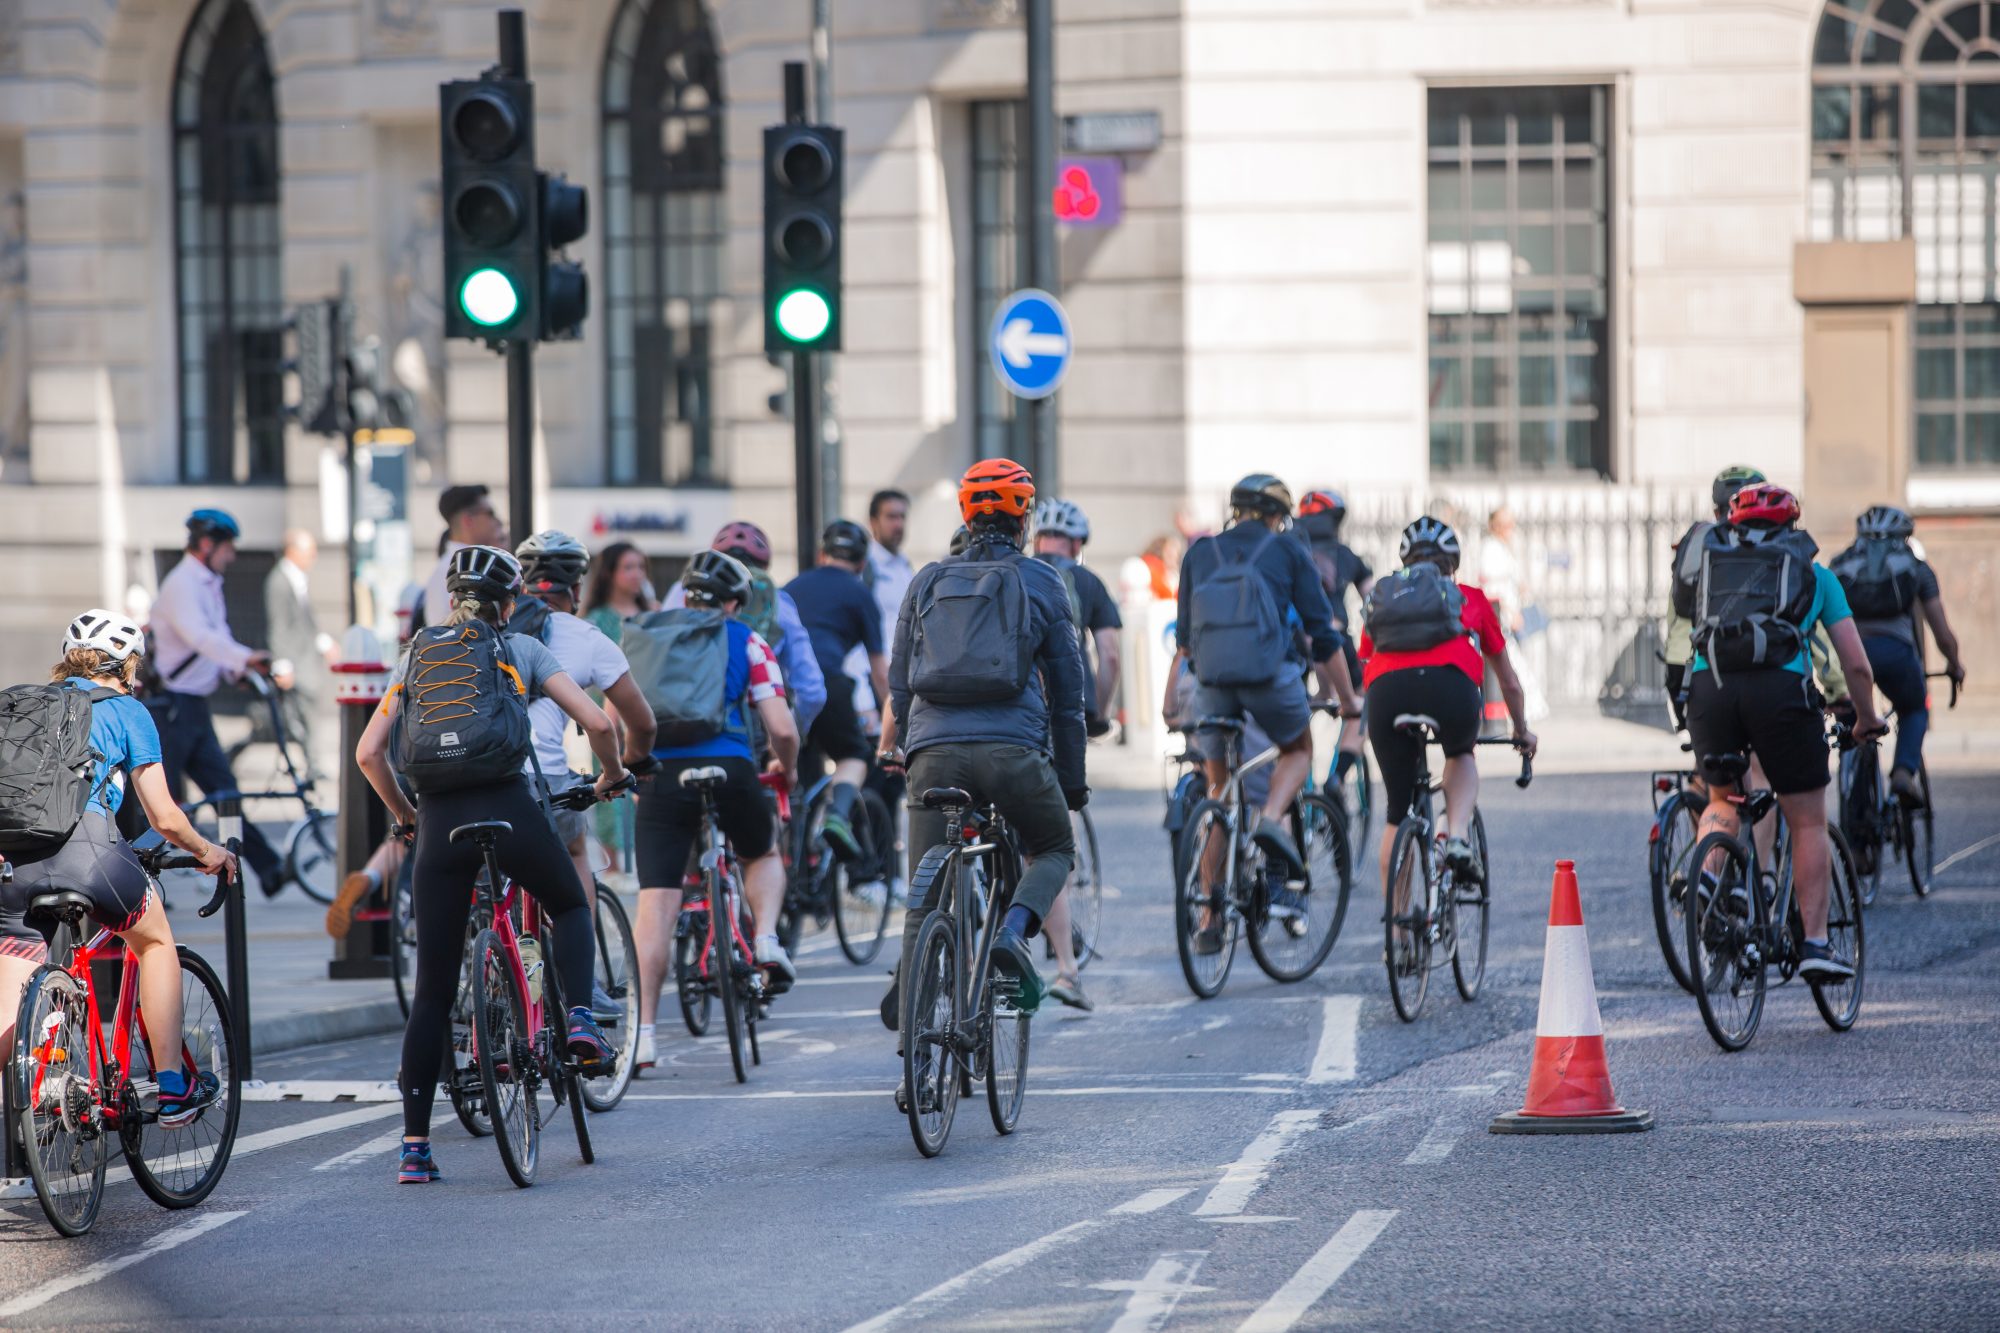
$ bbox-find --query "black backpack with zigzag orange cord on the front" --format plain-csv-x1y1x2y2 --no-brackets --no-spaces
390,620,534,795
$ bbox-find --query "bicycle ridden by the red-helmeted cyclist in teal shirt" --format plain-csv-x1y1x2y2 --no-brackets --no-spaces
1686,748,1866,1051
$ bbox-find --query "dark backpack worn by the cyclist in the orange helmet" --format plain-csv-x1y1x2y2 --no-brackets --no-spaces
910,542,1036,705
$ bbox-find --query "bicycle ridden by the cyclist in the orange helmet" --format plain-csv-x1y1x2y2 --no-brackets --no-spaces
898,787,1032,1157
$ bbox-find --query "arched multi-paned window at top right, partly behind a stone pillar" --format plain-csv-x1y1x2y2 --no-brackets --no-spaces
1812,0,2000,470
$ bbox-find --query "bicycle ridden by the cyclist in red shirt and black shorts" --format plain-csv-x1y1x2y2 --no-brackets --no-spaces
1382,713,1534,1023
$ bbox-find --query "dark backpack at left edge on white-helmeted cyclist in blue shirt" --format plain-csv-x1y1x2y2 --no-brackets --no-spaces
0,685,118,853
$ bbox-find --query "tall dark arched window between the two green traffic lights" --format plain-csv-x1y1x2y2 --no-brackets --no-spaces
604,0,728,486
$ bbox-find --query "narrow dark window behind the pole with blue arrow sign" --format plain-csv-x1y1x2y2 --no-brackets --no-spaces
966,100,1032,458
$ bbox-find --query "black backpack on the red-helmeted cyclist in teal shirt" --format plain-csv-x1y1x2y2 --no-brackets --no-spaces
1694,524,1818,677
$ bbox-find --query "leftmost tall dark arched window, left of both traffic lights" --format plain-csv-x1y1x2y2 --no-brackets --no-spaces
172,0,284,482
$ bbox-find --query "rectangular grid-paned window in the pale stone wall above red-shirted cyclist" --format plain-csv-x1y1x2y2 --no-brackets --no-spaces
1428,88,1612,476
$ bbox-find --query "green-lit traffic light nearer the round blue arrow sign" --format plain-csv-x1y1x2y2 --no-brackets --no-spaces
764,124,846,352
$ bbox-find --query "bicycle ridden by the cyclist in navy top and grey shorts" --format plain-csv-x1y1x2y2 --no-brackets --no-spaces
1174,705,1354,999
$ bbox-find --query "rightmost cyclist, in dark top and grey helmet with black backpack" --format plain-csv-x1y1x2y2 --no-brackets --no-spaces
1832,504,1966,805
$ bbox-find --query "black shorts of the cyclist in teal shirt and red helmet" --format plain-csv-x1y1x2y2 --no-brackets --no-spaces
1688,667,1826,797
